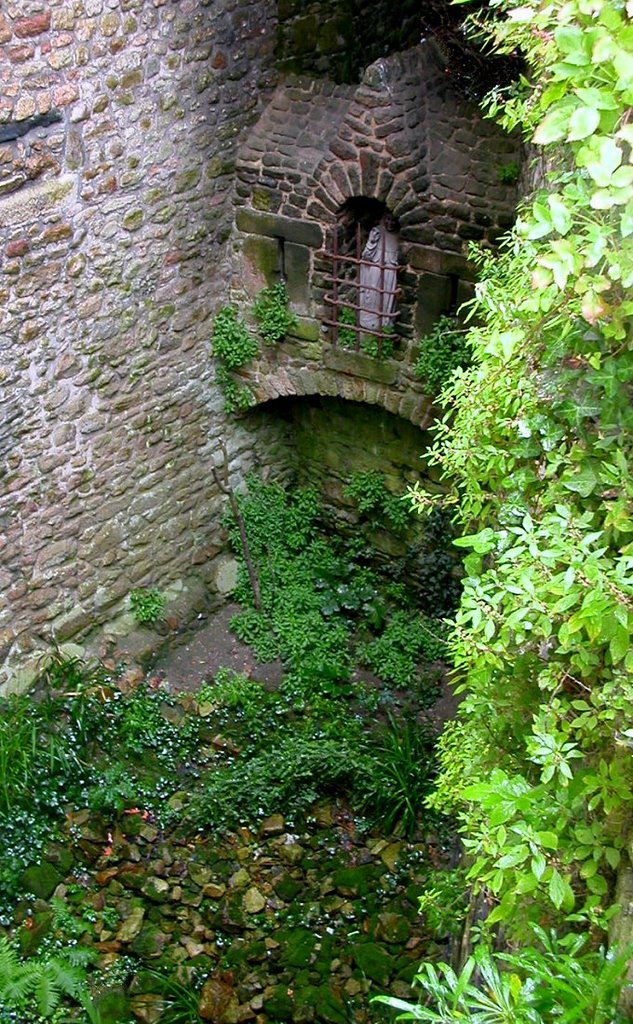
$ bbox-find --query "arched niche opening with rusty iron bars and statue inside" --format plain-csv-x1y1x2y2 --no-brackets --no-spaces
324,205,402,358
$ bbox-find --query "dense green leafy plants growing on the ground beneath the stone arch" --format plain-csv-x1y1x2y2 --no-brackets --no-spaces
225,474,447,697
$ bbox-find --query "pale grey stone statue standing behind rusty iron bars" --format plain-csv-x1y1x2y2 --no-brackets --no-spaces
358,213,398,331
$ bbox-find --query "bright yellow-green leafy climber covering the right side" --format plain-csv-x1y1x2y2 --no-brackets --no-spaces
403,0,633,958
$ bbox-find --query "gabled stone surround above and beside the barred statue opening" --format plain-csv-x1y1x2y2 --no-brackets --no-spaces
234,41,520,346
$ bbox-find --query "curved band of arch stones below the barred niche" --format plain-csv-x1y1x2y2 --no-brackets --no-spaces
241,365,435,430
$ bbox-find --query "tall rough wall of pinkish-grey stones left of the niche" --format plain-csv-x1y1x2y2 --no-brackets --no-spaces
0,0,275,685
